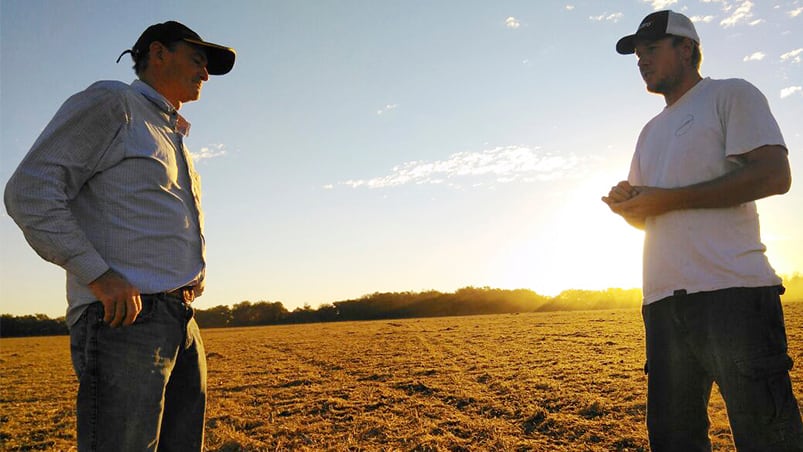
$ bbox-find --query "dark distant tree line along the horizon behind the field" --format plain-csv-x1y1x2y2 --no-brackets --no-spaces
0,274,803,337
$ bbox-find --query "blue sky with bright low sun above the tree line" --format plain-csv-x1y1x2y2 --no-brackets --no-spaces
0,0,803,317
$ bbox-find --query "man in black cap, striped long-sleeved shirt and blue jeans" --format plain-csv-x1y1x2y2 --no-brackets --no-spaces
5,21,235,451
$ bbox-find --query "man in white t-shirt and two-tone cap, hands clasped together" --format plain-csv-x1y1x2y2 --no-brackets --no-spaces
603,11,803,452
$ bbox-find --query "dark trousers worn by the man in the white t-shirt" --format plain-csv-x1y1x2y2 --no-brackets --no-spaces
642,287,803,452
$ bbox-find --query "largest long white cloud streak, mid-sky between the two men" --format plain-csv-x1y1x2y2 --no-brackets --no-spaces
338,146,582,188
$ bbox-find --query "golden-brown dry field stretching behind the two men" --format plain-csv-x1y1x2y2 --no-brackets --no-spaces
0,303,803,451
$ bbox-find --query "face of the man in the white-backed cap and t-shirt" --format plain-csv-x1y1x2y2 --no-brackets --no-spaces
635,37,683,95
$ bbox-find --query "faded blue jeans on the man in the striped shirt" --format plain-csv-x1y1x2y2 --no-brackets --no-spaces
70,294,206,451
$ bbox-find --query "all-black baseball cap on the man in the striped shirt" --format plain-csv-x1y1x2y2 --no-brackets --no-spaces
117,20,236,75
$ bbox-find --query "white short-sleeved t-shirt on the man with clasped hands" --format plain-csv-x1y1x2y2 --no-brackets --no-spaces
628,78,786,304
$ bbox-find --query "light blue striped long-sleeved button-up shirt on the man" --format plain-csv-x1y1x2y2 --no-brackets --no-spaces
5,80,205,325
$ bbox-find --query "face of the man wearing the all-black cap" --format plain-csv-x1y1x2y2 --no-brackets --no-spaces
162,41,209,108
